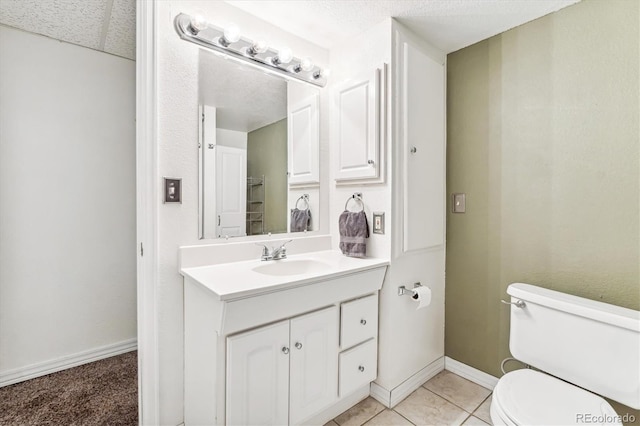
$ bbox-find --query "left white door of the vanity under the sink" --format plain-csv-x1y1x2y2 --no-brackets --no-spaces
228,321,289,425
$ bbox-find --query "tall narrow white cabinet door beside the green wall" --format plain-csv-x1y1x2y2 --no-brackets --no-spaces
397,39,446,252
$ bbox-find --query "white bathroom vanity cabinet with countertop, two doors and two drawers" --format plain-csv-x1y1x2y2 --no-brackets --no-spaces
181,250,388,425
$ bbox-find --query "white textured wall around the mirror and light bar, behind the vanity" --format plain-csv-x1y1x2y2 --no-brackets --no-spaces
155,0,328,425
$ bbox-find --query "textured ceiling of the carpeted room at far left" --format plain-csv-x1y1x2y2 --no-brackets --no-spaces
0,0,136,59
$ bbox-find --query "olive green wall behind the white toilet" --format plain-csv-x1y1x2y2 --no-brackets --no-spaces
445,0,640,418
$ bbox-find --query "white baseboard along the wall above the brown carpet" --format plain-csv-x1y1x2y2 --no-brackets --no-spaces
0,339,138,387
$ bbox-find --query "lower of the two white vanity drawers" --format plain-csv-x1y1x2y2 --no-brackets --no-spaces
339,339,378,397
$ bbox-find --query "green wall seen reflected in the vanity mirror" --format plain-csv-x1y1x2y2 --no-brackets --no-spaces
247,119,287,234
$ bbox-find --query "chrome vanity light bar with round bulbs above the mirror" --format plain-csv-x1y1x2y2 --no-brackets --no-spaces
174,13,329,87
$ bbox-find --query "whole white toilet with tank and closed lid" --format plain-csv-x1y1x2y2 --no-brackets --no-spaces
491,283,640,426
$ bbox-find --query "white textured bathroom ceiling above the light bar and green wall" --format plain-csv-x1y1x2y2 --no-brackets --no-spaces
227,0,579,53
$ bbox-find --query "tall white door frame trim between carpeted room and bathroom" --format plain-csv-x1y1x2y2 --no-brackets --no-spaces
136,0,160,425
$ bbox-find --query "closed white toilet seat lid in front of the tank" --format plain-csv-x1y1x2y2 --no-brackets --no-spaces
491,369,622,426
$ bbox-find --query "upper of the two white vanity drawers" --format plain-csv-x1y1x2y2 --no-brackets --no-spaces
340,293,378,349
